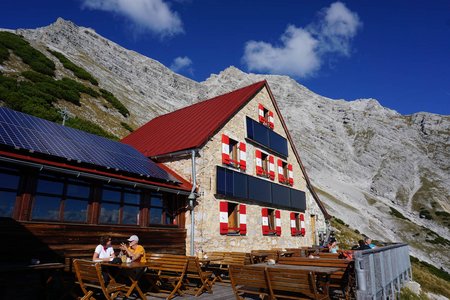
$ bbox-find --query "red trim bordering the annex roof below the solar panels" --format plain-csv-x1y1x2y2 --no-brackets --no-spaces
0,150,192,191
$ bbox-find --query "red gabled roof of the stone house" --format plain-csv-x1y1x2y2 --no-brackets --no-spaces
122,80,267,157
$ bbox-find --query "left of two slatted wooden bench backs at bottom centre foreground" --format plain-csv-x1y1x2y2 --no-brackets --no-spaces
229,265,269,299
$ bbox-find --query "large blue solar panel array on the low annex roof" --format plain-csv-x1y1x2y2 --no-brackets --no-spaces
0,107,179,182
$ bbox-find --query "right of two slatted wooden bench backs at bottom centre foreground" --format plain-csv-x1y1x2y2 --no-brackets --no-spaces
265,268,328,300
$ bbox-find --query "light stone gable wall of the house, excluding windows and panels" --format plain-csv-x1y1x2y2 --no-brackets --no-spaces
166,88,325,254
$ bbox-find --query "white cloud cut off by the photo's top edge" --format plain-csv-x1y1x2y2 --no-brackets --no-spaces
82,0,183,37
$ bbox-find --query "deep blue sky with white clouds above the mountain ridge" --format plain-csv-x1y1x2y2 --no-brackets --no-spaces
0,0,450,115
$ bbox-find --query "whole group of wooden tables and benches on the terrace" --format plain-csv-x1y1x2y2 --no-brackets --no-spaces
64,249,355,299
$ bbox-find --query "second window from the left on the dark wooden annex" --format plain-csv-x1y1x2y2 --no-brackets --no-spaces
31,174,91,223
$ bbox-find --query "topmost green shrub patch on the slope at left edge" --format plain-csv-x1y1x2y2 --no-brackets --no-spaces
0,31,55,76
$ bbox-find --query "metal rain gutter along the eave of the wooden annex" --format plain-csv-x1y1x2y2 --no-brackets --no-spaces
0,156,190,196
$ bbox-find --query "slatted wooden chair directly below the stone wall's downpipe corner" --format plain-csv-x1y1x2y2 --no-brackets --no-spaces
185,256,213,297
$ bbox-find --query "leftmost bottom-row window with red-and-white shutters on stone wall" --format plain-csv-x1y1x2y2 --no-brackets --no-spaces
220,201,247,235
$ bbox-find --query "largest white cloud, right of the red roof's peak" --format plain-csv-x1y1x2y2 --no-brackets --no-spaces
242,2,362,77
